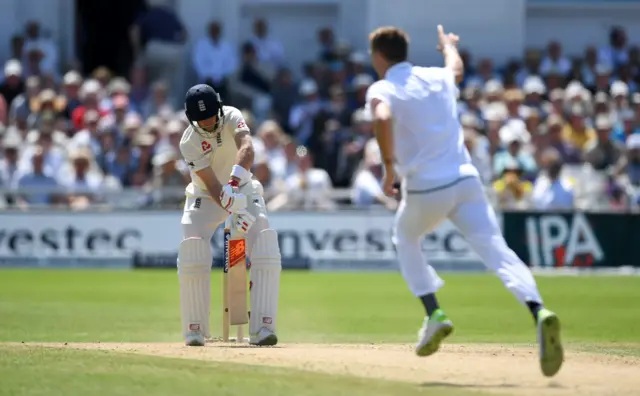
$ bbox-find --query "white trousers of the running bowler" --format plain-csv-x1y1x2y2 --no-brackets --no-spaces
393,177,542,304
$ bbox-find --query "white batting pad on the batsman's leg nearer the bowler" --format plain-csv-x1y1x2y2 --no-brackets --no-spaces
249,229,282,335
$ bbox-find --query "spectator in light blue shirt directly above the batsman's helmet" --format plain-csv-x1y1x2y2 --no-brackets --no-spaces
192,22,238,98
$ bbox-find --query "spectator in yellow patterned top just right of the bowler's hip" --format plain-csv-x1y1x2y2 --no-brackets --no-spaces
493,161,533,210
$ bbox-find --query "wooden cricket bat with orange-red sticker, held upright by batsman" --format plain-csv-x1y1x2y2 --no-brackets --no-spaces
222,215,249,342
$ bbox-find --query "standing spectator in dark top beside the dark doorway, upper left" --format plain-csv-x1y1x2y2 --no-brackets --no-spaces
130,0,187,100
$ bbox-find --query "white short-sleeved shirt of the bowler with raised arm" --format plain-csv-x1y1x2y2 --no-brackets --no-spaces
367,62,479,190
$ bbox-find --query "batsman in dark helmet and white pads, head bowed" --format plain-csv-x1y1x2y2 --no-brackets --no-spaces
178,84,282,346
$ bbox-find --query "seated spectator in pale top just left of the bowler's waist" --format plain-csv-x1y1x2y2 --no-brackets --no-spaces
351,139,398,210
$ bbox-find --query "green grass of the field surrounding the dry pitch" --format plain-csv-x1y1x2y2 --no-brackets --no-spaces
0,270,640,396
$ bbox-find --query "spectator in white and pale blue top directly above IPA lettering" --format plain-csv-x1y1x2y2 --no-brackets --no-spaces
532,148,574,211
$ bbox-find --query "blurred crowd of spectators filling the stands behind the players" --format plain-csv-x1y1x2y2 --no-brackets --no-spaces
0,5,640,211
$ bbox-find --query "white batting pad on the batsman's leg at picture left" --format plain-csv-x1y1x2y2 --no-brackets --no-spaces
178,238,213,337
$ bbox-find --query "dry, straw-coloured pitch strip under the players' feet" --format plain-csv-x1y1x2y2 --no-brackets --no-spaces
23,343,640,396
